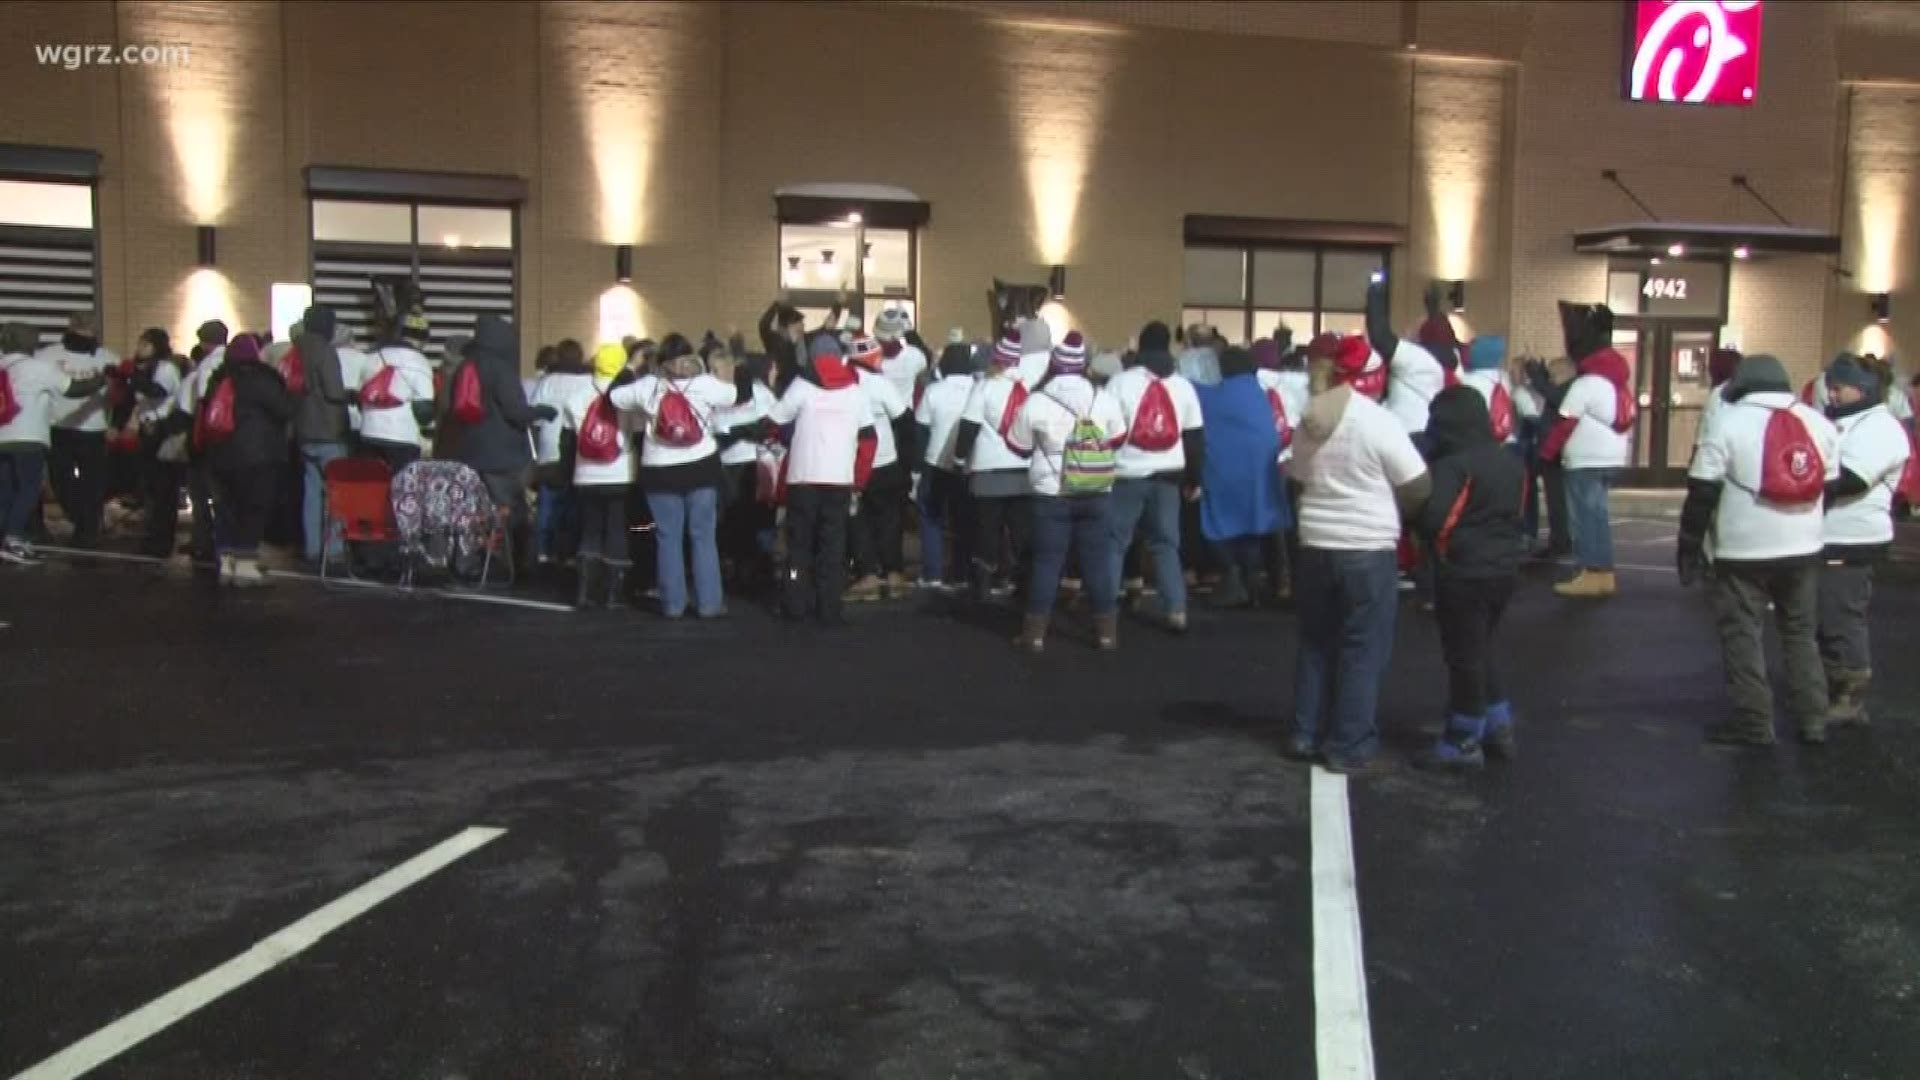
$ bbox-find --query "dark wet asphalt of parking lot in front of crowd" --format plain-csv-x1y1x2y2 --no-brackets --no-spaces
0,521,1920,1080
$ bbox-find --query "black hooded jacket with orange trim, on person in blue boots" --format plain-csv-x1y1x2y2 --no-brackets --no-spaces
1413,386,1526,578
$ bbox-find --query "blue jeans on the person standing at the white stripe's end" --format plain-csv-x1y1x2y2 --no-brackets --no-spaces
1294,546,1400,765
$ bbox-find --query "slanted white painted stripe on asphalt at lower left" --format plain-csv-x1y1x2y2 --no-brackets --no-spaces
13,826,507,1080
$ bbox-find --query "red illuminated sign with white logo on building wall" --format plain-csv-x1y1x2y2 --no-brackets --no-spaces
1626,0,1761,106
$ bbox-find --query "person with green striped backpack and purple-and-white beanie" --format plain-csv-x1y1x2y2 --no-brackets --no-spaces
1006,331,1127,653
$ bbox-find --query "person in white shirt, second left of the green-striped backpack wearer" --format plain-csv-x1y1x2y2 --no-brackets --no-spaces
914,340,975,588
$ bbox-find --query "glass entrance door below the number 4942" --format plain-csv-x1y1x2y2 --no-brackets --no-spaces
1615,319,1720,486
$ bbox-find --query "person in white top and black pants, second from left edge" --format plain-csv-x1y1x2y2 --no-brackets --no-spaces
35,311,119,548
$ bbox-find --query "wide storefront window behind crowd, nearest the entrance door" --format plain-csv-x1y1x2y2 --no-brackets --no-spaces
1181,244,1386,344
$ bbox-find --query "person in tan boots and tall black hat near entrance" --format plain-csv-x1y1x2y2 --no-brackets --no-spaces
1540,302,1638,600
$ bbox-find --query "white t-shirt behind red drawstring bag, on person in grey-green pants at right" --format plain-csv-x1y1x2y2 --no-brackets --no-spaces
1688,390,1839,563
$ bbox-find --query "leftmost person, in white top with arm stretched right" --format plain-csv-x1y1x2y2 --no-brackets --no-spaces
0,323,106,567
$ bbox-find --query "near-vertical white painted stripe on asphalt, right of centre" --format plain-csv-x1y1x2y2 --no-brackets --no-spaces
1308,765,1373,1080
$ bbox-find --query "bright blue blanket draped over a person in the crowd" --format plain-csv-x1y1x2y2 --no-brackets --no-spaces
1194,375,1294,540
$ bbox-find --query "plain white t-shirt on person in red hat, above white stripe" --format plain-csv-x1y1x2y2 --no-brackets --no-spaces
1286,394,1427,552
